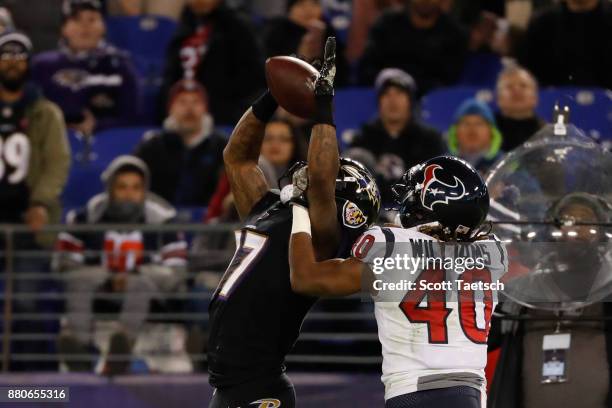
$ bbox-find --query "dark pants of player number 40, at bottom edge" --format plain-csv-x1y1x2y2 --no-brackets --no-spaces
385,386,484,408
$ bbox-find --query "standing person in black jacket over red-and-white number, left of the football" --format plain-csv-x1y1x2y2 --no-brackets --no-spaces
162,0,264,124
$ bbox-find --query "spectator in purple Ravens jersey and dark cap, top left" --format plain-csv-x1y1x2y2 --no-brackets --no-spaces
32,0,139,135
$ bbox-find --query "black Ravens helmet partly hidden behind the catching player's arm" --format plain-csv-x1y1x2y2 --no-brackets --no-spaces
278,157,380,228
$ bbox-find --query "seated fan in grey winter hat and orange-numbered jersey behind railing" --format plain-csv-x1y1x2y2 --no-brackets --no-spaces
54,156,187,375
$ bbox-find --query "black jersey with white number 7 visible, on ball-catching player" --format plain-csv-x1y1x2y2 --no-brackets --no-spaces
208,192,361,388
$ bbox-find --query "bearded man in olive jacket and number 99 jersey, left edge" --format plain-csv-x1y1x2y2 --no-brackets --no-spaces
0,31,70,231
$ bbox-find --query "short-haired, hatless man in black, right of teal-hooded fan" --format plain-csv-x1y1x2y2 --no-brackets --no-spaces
495,65,545,152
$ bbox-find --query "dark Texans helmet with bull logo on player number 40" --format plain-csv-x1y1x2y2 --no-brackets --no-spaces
392,156,489,235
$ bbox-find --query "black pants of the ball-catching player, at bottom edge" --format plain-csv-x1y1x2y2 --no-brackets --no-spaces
208,374,295,408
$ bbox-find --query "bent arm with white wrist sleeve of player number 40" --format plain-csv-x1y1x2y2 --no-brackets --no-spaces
289,204,372,296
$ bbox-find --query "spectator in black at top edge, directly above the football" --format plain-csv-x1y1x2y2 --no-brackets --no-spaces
264,0,348,85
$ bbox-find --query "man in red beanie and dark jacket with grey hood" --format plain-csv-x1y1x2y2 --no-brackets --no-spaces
135,80,226,207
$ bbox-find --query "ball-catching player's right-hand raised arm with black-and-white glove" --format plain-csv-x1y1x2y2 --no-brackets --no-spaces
307,37,340,260
